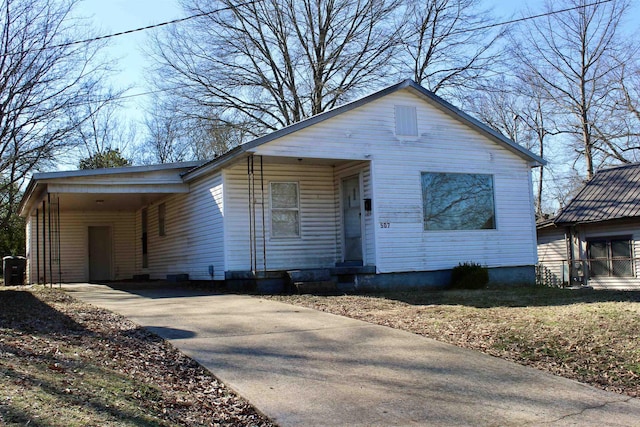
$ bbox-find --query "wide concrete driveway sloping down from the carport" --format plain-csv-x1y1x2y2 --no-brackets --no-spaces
65,285,640,426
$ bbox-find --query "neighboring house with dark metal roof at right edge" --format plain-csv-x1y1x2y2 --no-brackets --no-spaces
538,164,640,289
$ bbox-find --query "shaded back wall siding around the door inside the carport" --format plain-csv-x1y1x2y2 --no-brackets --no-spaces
27,206,136,283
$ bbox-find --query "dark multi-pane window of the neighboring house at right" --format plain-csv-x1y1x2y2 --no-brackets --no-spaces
587,237,633,277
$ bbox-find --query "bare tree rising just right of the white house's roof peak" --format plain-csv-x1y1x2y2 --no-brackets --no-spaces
399,0,505,93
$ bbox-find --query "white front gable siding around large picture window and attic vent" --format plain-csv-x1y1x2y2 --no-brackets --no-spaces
255,91,536,273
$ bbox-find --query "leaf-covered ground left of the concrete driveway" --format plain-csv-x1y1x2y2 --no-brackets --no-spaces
0,287,274,426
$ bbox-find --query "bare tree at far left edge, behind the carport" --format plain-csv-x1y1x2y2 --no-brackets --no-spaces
0,0,115,254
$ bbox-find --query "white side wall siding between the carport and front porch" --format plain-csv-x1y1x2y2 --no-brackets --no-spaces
135,173,225,280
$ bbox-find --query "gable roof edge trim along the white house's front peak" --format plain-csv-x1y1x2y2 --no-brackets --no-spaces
184,79,547,181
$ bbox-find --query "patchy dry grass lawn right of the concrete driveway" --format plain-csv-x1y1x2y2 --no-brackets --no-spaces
273,287,640,397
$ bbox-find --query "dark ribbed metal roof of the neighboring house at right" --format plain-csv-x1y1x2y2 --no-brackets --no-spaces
554,163,640,224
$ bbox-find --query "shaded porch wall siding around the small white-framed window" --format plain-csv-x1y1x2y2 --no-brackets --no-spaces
224,160,338,271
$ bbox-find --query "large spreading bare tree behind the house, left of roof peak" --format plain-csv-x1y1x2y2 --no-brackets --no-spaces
148,0,399,135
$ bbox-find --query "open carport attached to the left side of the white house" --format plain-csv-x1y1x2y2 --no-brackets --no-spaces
19,162,199,284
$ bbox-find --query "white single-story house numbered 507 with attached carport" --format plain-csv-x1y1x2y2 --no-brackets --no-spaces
21,80,544,288
